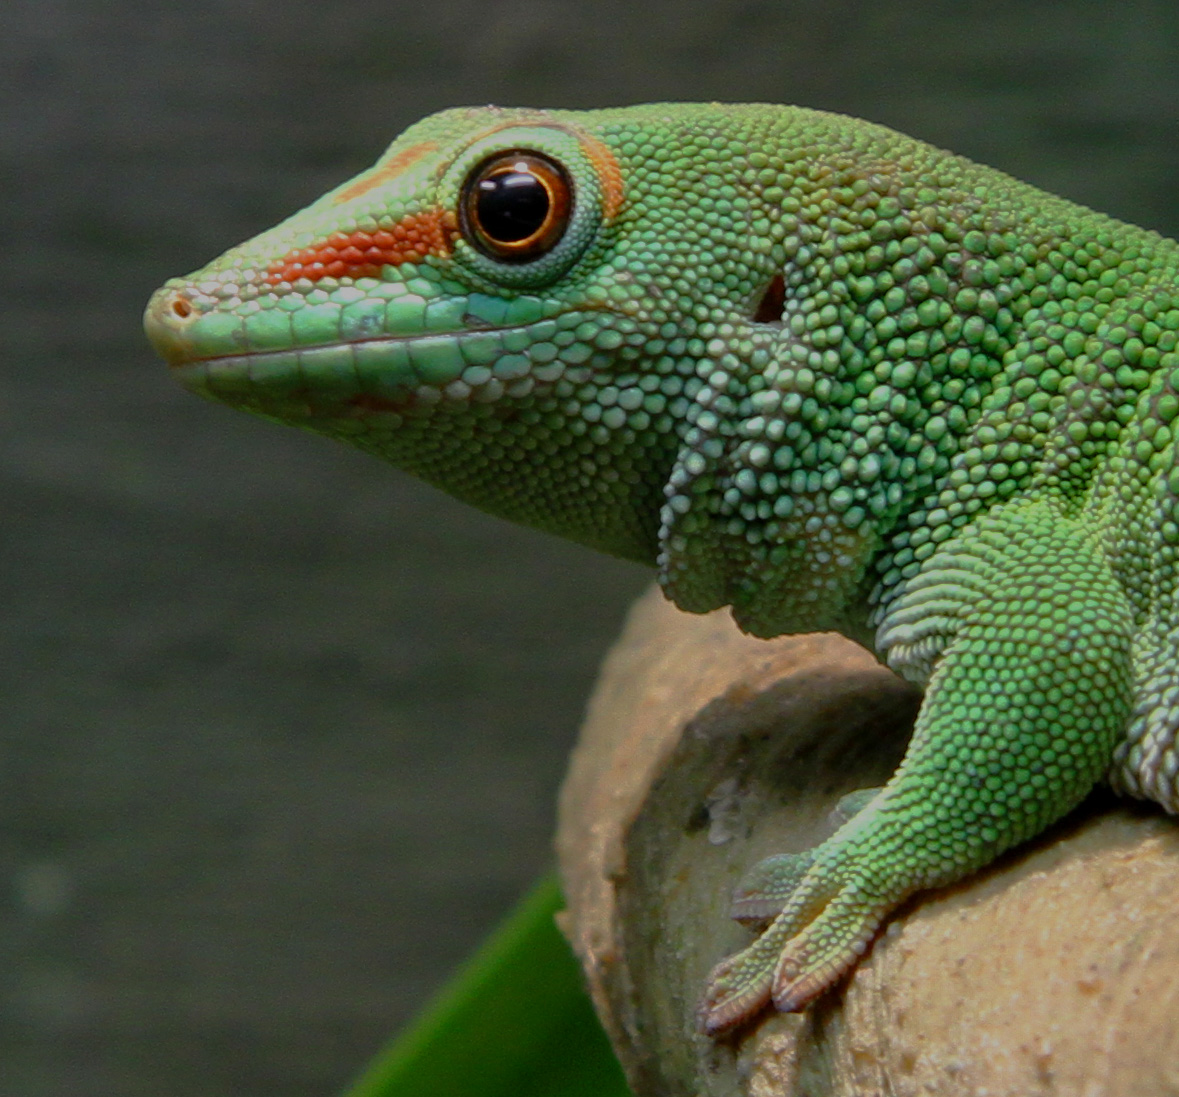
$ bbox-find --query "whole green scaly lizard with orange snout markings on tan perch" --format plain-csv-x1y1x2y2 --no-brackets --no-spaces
146,104,1179,1033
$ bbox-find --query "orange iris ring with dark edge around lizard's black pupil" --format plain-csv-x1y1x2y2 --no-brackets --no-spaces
459,149,573,263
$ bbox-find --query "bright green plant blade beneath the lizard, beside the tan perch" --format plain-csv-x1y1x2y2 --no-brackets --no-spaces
344,876,631,1097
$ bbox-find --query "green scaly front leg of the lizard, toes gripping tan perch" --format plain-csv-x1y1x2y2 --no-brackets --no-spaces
698,501,1132,1034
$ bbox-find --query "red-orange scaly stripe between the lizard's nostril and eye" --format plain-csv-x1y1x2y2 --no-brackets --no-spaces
265,209,459,285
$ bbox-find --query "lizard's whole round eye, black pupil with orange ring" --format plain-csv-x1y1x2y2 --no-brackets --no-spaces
460,152,573,263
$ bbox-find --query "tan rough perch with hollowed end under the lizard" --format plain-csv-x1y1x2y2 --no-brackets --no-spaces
558,591,1179,1097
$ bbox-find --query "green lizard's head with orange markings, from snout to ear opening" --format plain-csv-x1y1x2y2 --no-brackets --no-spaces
145,107,780,563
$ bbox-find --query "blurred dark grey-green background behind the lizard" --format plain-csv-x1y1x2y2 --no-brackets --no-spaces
0,0,1179,1097
